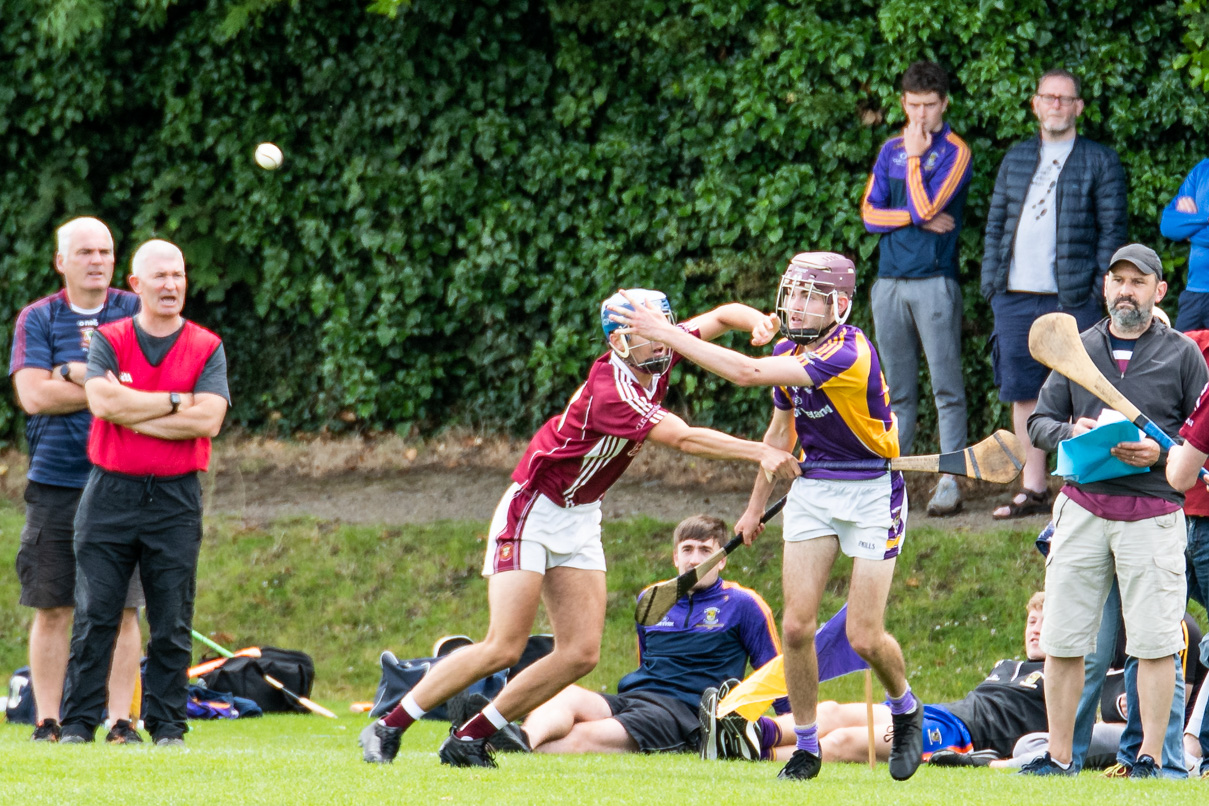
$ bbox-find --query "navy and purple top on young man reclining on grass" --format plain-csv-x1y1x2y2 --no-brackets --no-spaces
617,579,788,713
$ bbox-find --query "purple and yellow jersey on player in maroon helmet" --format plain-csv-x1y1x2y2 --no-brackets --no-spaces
773,325,898,479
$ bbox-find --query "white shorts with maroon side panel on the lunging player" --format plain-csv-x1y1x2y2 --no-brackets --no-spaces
482,483,605,576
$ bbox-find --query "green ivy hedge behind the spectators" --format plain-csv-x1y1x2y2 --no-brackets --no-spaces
0,0,1209,448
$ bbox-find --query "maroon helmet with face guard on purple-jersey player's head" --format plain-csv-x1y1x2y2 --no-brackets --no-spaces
776,253,856,344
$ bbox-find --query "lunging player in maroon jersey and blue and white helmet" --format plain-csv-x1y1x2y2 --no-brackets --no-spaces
360,290,800,766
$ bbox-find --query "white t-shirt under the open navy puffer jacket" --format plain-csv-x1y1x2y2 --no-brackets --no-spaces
1007,138,1075,294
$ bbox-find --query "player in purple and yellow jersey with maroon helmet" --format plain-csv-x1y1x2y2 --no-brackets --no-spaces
614,253,924,781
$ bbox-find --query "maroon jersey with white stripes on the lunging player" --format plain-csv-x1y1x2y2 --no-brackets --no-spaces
513,329,699,506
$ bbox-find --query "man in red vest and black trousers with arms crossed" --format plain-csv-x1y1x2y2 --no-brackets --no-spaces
60,240,230,747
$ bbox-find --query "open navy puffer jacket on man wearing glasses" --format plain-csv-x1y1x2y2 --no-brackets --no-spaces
982,135,1129,307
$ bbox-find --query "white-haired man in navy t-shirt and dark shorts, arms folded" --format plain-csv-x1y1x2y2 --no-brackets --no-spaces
8,218,143,743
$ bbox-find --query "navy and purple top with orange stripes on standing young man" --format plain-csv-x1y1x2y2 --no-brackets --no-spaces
861,123,971,279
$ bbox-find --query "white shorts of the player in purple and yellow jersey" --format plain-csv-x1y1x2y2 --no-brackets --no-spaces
785,472,907,559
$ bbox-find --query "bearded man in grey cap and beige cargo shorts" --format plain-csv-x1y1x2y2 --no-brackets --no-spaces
1022,244,1209,778
